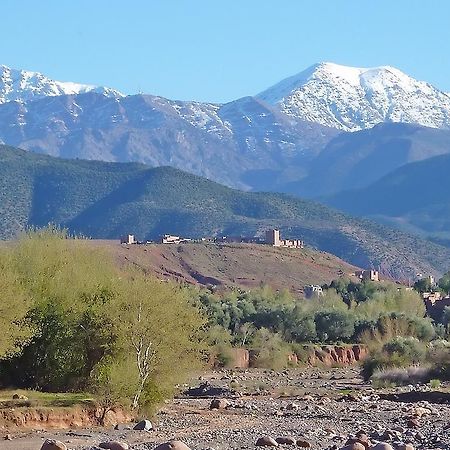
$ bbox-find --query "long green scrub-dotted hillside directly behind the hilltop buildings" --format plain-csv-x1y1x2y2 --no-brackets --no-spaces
0,146,450,278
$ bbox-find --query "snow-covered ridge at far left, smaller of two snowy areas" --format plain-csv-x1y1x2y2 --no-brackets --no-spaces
0,65,123,104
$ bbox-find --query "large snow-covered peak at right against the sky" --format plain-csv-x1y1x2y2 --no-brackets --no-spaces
257,63,450,131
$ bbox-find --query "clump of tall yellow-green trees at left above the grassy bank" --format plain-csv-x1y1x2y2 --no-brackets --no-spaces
0,228,204,414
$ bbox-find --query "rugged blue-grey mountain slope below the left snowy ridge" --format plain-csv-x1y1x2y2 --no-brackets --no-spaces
0,93,337,190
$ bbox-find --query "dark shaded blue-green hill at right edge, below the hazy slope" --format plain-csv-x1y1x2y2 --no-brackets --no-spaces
327,154,450,242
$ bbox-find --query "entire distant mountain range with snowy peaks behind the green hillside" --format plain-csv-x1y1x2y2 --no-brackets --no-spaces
0,63,450,245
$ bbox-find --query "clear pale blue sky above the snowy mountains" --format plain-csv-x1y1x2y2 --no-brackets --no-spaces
0,0,450,102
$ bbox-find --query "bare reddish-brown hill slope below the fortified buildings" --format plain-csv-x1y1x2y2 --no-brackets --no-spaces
97,241,356,292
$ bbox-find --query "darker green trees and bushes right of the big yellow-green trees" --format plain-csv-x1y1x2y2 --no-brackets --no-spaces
200,278,449,367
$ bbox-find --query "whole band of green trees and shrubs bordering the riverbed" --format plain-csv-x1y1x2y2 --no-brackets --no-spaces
0,227,450,411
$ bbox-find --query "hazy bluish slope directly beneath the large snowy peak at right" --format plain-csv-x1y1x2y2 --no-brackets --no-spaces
282,123,450,198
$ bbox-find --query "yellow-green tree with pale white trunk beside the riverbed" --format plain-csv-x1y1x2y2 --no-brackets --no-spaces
110,272,205,408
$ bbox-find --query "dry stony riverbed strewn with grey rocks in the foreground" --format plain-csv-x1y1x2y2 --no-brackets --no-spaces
0,369,450,450
